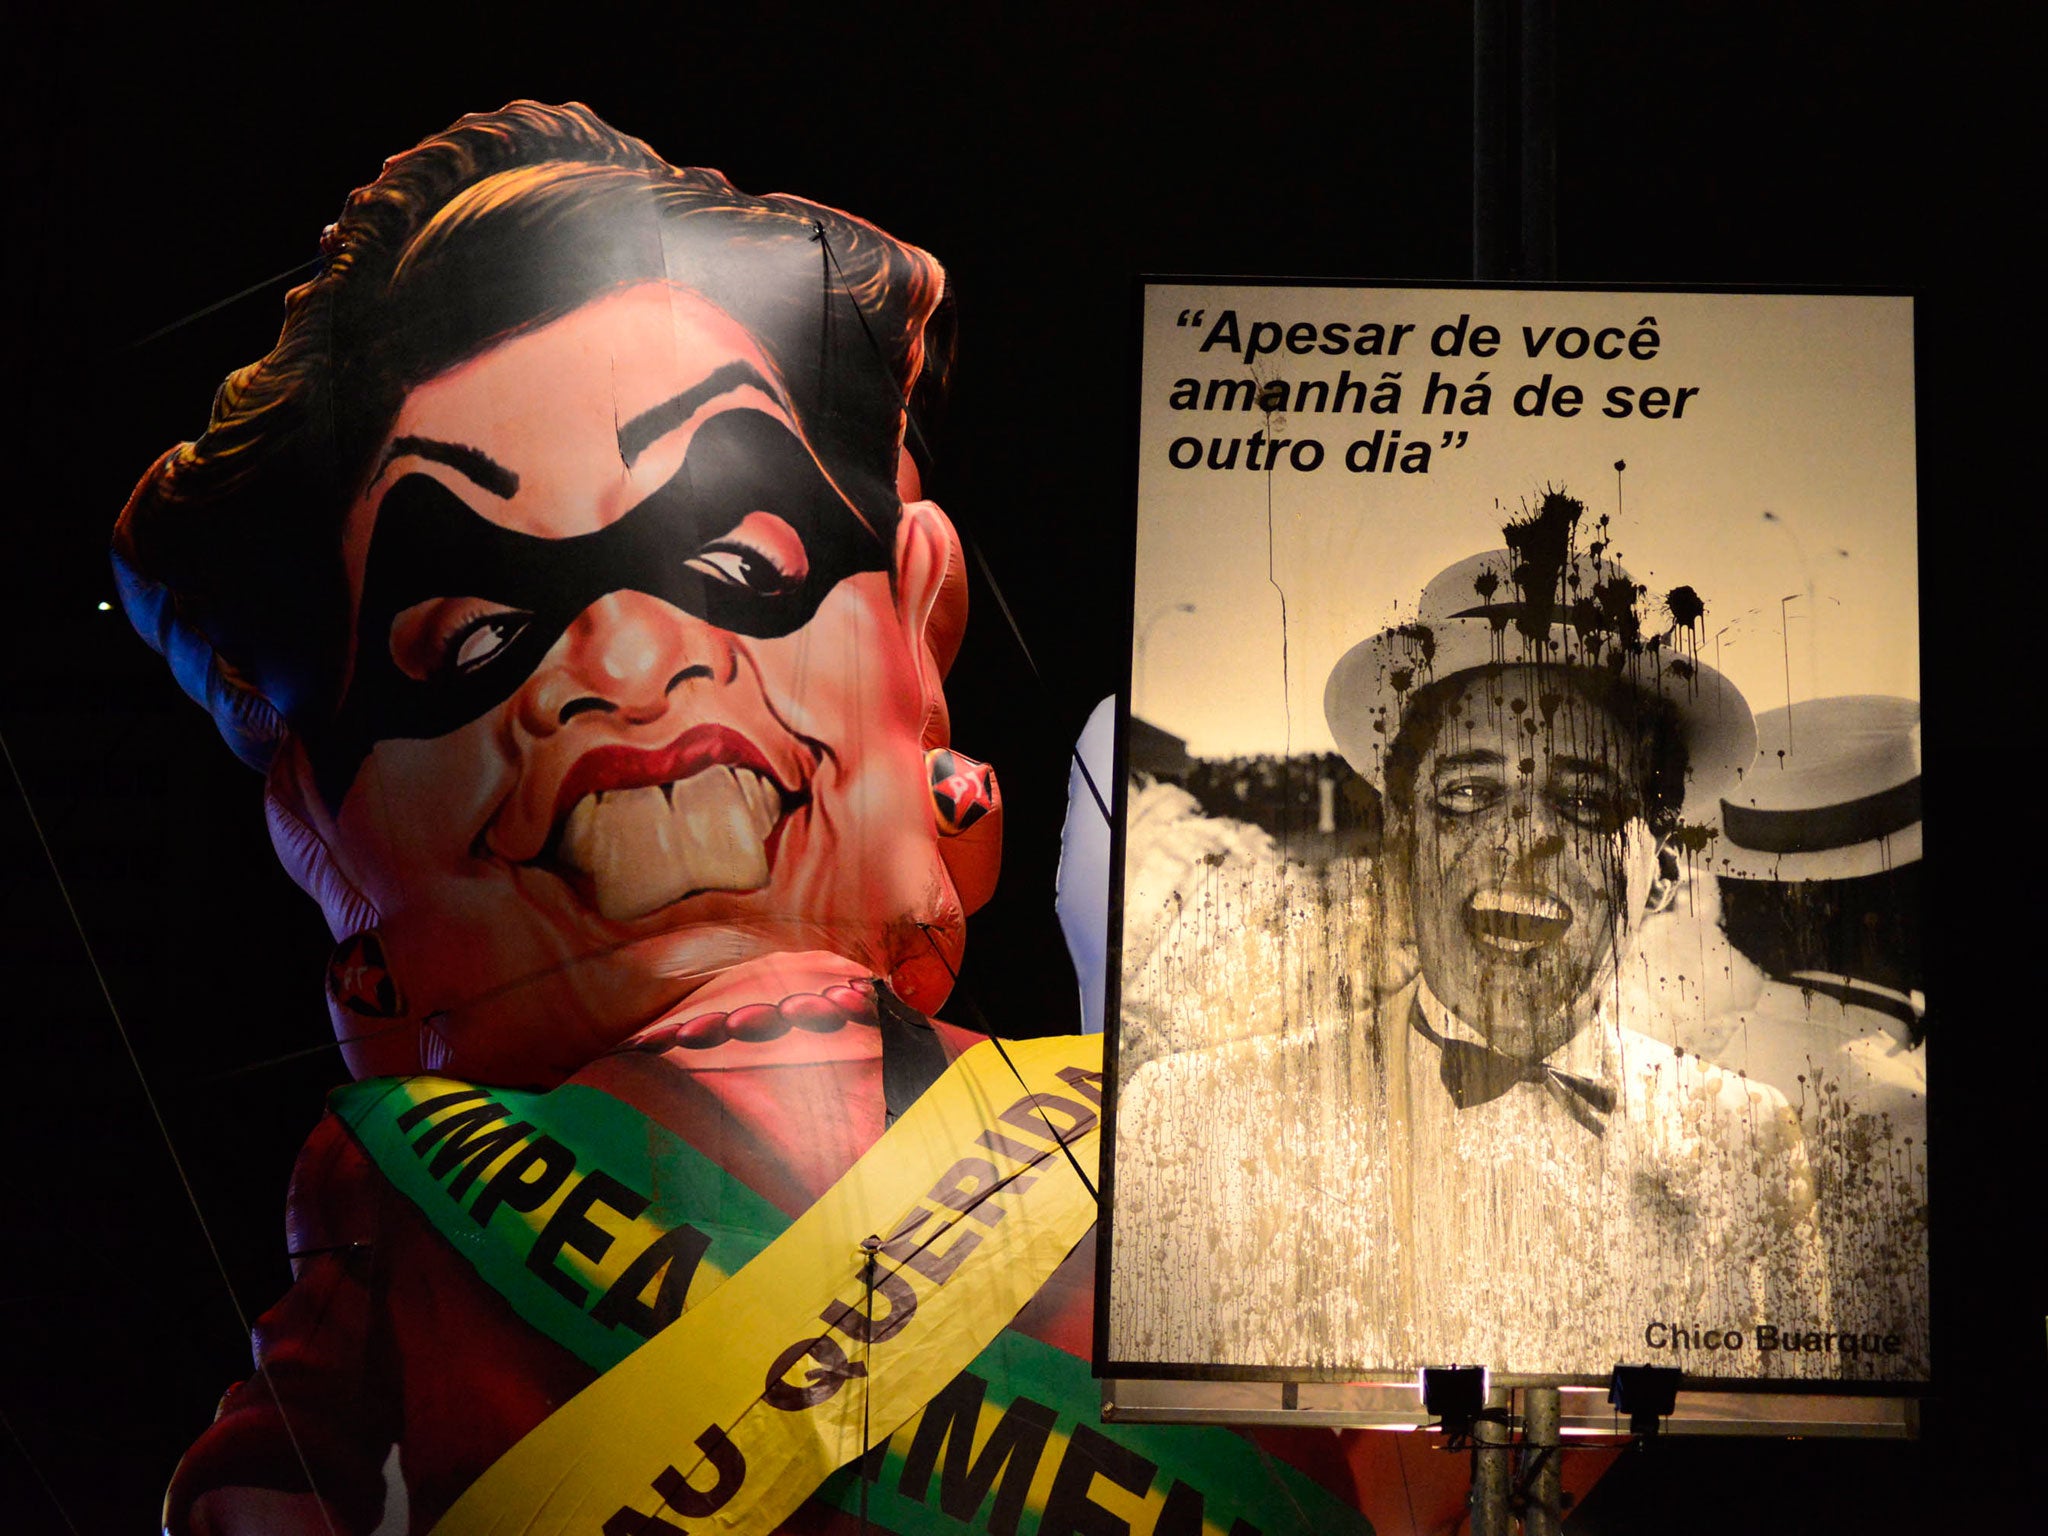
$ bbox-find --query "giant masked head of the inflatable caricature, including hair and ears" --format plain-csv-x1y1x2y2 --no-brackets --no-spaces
115,102,997,1083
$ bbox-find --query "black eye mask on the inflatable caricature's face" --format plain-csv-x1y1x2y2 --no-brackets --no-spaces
307,410,889,809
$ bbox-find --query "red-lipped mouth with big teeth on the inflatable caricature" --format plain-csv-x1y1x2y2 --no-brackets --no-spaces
537,725,809,922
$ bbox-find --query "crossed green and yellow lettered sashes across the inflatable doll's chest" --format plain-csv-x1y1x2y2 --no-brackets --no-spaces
334,1036,1368,1536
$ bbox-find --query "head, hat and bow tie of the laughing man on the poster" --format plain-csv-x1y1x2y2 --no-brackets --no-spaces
1323,539,1755,1120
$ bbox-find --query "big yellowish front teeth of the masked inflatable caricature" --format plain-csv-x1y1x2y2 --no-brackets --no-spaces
561,766,782,922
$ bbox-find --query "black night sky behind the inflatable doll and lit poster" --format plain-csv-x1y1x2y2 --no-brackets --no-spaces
0,0,2015,1532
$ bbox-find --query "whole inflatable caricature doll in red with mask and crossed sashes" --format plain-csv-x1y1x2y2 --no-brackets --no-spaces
115,102,1464,1536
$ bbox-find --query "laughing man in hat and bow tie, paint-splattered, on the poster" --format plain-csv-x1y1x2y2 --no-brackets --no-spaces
1110,514,1867,1376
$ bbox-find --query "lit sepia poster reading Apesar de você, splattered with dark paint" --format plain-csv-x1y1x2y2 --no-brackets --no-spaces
1100,281,1929,1386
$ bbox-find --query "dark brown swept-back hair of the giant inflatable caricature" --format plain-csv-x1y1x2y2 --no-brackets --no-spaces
113,102,946,766
